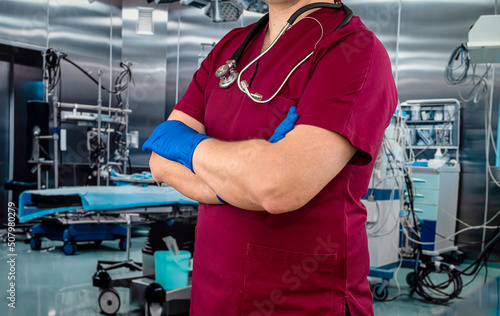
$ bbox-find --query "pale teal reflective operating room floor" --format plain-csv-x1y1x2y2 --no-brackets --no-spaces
0,230,500,316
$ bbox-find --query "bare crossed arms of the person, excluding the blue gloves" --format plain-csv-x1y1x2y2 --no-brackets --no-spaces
149,110,357,214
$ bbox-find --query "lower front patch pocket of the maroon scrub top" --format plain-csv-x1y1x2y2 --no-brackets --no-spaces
241,244,337,316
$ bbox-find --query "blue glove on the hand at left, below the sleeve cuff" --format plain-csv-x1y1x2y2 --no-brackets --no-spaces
142,120,211,173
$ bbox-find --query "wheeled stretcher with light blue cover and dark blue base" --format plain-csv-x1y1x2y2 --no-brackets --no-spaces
18,185,198,255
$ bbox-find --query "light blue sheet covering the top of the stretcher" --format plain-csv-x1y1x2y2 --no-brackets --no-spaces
18,185,198,223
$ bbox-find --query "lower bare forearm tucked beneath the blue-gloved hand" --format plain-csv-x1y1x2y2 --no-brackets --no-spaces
149,152,221,204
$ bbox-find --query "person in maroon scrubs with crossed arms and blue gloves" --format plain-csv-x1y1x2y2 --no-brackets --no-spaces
143,0,397,316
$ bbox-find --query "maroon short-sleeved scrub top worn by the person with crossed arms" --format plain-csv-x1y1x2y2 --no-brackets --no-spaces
175,9,397,316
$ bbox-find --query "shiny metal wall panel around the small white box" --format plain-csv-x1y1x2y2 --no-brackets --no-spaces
122,0,170,169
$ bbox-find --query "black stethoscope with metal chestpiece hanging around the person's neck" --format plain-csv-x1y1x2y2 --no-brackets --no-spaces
215,2,353,103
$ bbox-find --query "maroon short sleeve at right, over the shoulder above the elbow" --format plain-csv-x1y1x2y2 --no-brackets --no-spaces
297,31,397,165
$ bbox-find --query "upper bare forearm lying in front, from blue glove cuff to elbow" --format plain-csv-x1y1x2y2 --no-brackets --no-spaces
193,139,315,213
